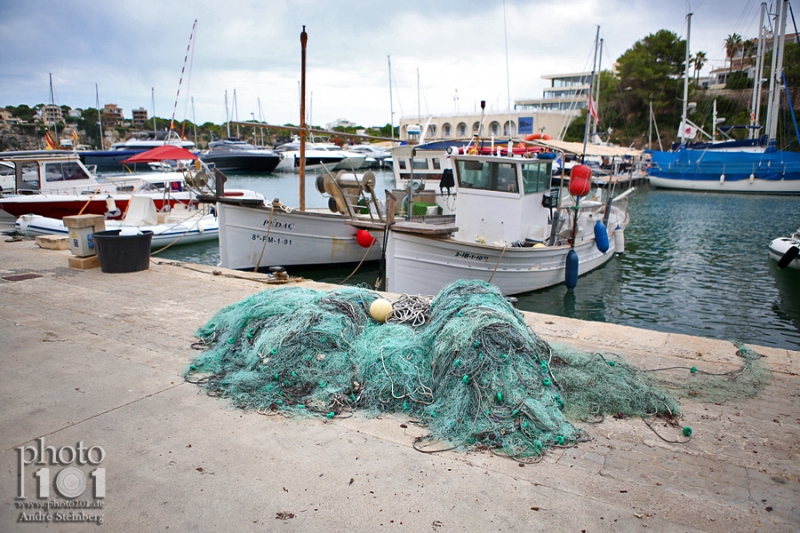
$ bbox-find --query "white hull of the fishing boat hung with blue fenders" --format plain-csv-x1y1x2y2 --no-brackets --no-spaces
386,231,615,295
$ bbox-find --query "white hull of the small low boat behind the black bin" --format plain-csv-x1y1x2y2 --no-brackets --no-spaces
16,215,219,249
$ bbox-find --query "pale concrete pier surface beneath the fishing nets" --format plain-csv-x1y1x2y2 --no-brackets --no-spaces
0,238,800,532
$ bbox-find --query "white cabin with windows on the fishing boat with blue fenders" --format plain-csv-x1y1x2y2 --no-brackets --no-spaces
453,155,555,246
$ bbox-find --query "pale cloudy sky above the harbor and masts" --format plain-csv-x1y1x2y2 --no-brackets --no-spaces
0,0,772,126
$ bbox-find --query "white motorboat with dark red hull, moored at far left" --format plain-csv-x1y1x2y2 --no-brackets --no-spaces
0,146,264,219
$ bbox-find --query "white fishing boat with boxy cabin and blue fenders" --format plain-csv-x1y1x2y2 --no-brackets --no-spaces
372,155,633,295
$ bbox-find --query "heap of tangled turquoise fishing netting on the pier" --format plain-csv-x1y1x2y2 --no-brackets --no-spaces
186,281,765,459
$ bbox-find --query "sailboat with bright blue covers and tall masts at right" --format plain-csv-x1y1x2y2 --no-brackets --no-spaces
647,0,800,194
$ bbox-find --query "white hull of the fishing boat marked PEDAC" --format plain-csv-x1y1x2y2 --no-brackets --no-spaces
217,203,383,269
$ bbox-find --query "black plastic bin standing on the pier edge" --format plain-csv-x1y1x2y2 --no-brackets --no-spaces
92,229,153,274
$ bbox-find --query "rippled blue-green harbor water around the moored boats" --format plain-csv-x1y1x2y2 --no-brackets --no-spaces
159,172,800,350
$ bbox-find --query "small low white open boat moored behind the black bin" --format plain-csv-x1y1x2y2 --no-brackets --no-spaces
15,196,219,249
